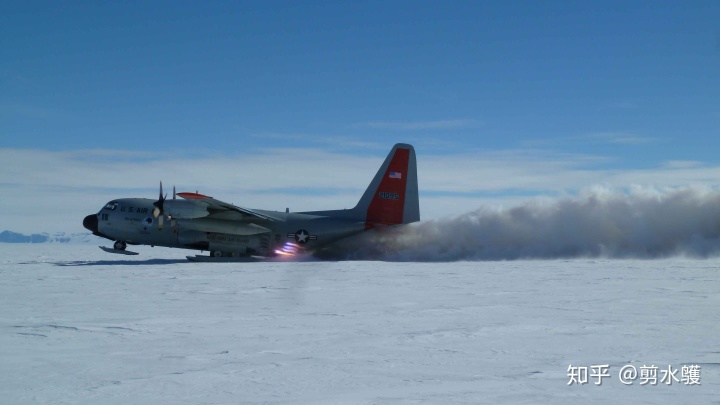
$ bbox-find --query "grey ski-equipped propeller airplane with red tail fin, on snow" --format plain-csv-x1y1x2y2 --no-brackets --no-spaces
83,143,420,261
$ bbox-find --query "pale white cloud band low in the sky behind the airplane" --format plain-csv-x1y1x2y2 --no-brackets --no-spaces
0,148,720,232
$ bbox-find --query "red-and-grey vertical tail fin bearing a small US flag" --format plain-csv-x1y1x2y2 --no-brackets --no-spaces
353,143,420,228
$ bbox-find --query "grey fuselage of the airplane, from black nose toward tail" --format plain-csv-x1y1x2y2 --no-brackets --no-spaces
84,198,366,256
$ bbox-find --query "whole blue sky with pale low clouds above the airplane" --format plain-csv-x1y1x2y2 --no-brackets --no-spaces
0,1,720,228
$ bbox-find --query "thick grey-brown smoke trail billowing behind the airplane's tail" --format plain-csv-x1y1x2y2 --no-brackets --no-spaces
315,187,720,261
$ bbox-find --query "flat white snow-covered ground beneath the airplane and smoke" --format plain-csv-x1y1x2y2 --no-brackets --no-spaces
0,244,720,404
